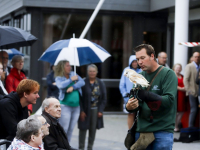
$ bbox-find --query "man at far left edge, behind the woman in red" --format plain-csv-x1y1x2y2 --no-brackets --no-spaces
0,51,11,81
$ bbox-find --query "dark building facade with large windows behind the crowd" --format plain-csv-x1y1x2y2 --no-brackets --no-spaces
0,0,200,111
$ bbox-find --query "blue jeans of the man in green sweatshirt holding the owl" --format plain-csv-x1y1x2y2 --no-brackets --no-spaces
135,131,173,150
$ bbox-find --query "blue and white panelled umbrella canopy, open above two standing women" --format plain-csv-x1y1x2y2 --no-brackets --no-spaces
39,38,111,66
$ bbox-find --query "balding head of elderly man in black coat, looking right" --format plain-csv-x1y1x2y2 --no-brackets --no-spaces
42,97,61,119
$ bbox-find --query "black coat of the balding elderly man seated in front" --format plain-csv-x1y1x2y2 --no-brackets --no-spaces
42,112,71,150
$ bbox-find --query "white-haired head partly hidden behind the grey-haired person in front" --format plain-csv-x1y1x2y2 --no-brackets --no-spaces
28,115,50,138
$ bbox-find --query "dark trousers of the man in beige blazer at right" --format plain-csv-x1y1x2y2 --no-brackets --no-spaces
189,95,198,127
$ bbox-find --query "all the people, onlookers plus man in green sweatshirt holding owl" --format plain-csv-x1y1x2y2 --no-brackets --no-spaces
0,44,200,150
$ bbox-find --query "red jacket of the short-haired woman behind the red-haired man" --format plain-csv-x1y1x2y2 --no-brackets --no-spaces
6,68,32,112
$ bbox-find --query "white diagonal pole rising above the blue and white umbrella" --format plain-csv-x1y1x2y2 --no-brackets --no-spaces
79,0,104,39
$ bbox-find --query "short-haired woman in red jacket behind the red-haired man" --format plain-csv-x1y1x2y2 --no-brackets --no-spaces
5,55,32,114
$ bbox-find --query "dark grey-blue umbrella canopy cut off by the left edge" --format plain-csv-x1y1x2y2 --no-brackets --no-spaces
0,26,37,49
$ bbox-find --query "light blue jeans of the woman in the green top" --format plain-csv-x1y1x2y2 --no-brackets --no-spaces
59,104,80,142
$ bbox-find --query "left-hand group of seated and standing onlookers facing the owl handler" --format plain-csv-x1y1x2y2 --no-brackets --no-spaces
0,52,107,150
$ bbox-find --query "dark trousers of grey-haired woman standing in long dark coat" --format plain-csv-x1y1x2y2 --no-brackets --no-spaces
79,108,97,150
